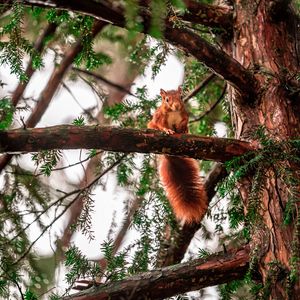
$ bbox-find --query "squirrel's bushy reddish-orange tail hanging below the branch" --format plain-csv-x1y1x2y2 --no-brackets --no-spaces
159,155,208,223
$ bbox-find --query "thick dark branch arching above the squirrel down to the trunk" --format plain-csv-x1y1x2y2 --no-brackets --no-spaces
4,0,257,103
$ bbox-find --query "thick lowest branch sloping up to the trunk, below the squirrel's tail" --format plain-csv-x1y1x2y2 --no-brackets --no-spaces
64,247,249,300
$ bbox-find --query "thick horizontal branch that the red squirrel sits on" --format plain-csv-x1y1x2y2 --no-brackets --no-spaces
0,125,256,161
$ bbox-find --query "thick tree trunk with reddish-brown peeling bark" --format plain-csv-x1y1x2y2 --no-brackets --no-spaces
227,0,300,299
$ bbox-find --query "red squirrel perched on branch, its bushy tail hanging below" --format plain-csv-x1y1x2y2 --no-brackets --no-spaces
147,86,208,223
